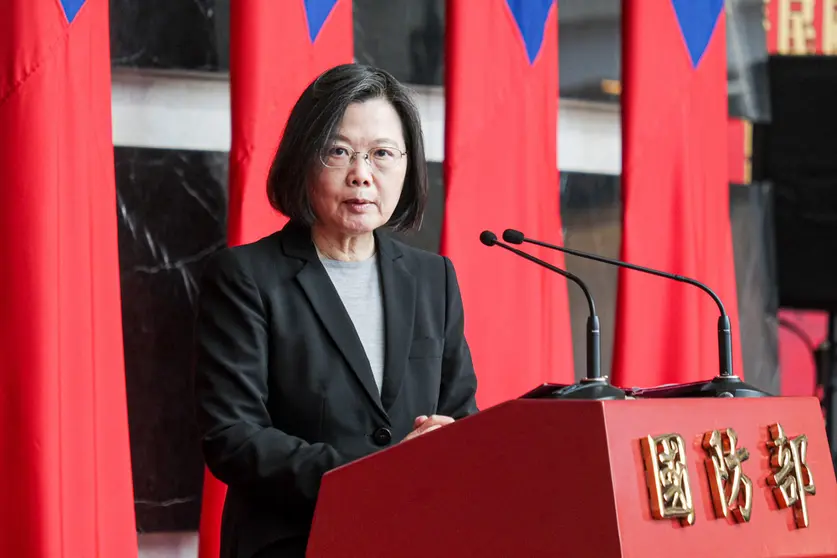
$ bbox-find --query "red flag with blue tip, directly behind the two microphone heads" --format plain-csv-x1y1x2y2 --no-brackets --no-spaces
442,0,573,407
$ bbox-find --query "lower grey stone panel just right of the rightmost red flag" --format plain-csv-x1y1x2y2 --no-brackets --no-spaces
730,183,780,394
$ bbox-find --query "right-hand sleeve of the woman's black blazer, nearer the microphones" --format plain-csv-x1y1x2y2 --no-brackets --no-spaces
438,257,477,419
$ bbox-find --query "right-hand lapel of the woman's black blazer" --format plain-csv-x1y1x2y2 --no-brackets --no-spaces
375,233,416,411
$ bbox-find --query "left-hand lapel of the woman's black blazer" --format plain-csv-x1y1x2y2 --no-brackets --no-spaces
284,225,389,424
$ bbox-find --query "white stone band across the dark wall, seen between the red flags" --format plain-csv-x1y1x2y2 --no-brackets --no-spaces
113,69,622,170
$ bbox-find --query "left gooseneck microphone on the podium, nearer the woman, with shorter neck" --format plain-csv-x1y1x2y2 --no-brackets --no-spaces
480,231,626,399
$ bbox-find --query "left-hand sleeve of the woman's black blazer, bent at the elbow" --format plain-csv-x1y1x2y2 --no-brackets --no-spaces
194,250,370,510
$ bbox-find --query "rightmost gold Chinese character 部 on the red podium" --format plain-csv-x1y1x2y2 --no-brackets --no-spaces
767,424,817,527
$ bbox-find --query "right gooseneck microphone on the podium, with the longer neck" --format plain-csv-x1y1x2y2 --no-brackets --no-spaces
503,229,770,397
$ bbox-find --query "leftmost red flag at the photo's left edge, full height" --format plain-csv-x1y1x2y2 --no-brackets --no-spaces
0,0,137,558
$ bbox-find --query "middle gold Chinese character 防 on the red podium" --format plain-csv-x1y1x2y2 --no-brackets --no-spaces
703,428,753,521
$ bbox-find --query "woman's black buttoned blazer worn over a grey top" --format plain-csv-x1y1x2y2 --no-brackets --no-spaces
195,224,477,558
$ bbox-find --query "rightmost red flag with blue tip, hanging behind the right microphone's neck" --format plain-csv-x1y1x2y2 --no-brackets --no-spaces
613,0,743,386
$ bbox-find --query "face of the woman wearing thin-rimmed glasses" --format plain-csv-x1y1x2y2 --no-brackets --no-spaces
311,99,407,236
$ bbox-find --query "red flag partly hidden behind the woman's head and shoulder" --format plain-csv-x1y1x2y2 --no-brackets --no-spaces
199,0,354,558
